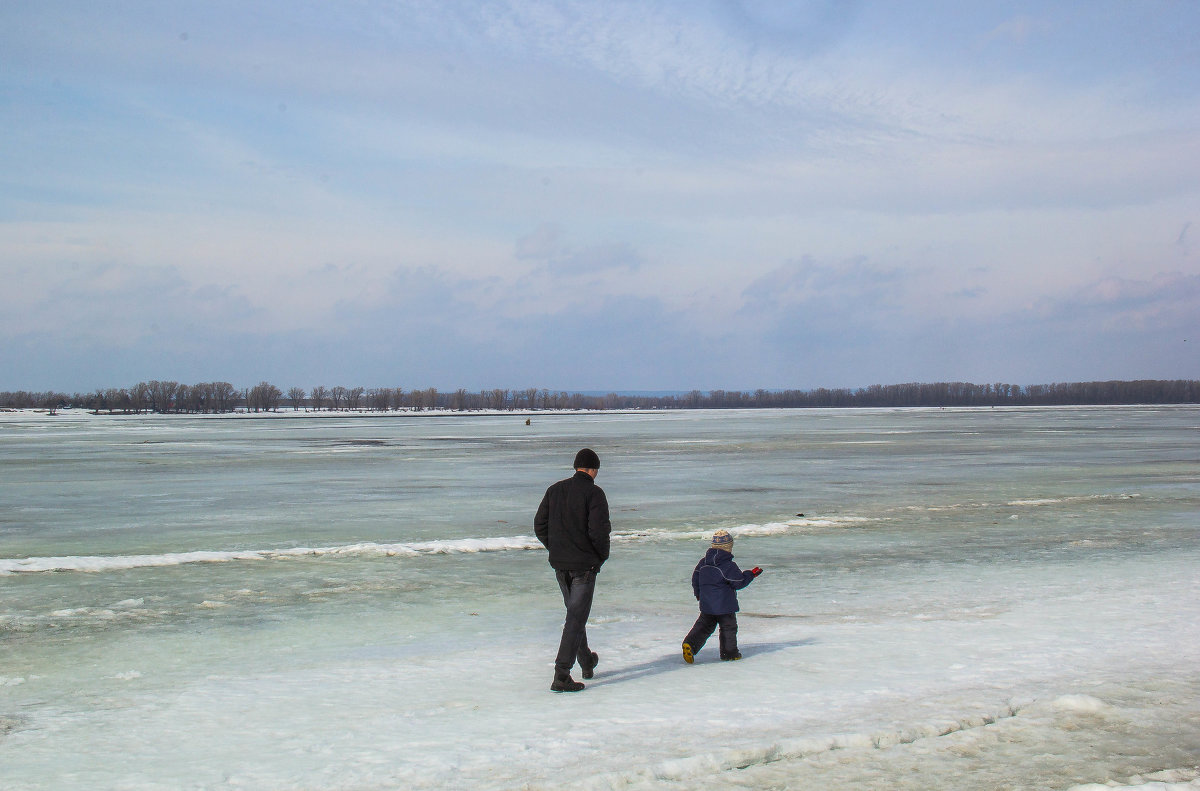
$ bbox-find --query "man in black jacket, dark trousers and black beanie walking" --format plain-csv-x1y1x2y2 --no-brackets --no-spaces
533,448,612,693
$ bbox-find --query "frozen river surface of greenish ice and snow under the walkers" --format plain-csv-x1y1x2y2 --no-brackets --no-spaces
0,407,1200,791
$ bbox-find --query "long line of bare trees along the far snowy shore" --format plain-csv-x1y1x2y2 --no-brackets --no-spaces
0,379,1200,414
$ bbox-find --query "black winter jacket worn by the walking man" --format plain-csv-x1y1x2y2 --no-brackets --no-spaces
533,472,612,571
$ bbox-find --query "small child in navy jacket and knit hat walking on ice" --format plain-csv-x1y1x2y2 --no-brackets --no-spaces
683,531,762,665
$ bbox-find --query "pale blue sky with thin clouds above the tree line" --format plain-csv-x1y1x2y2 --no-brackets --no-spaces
0,0,1200,392
